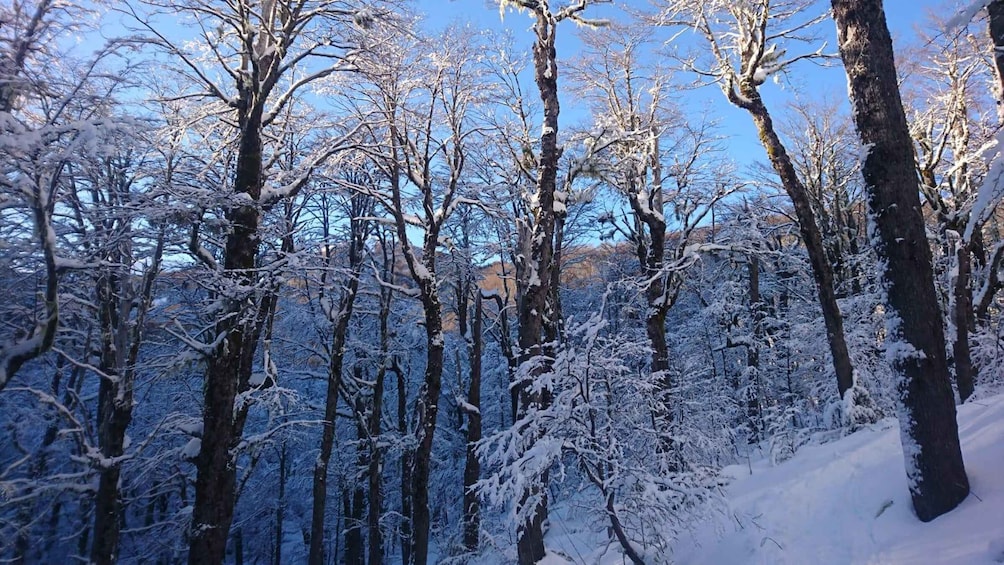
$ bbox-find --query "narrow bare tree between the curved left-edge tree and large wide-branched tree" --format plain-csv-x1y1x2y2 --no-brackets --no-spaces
67,144,171,565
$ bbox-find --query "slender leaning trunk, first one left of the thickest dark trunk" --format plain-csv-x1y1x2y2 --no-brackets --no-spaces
732,88,854,398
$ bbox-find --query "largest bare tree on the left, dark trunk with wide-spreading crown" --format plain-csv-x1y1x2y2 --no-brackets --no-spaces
123,0,374,564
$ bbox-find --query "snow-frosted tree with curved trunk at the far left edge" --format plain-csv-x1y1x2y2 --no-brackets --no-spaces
0,0,109,390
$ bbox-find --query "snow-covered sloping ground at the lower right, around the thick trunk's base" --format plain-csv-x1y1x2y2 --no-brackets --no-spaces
499,395,1004,565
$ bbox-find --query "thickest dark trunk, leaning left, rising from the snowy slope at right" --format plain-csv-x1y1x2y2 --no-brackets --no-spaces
832,0,969,522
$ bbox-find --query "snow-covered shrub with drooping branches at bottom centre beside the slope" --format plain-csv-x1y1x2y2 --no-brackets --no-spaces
478,299,718,562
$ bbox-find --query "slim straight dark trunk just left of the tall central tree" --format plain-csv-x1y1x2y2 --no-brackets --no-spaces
464,292,484,551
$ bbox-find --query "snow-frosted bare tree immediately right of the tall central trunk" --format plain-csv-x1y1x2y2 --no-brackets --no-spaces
570,26,734,455
